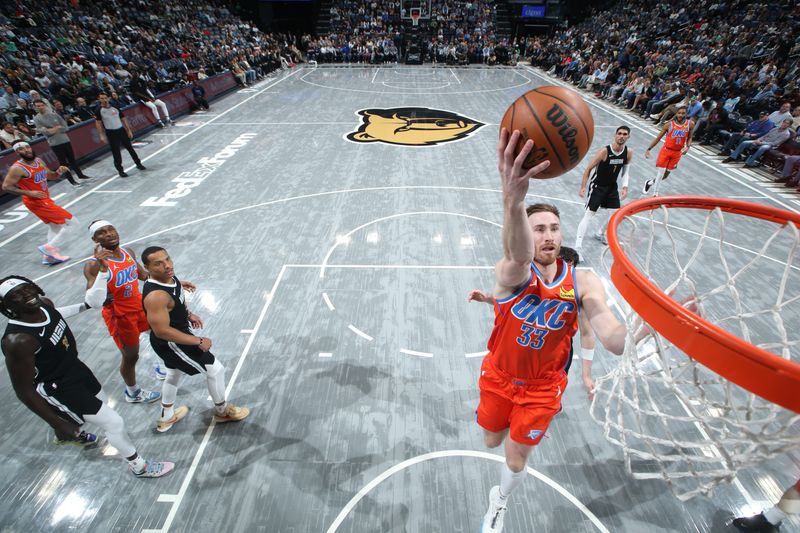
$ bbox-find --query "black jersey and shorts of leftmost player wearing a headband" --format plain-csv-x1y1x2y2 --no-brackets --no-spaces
3,302,103,425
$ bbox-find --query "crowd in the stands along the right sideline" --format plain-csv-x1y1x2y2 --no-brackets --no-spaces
527,0,800,187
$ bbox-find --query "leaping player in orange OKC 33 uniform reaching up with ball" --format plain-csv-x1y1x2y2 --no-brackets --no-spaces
477,128,626,533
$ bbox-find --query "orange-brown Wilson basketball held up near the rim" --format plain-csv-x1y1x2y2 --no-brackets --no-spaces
500,85,594,179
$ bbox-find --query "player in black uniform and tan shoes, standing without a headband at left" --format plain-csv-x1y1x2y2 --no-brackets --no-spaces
142,246,250,432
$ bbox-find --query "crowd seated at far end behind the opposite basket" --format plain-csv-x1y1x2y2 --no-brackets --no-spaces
303,0,519,64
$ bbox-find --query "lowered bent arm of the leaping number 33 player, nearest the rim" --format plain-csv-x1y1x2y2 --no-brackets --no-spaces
575,270,626,355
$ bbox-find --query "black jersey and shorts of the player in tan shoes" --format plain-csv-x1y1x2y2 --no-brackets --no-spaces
142,277,214,376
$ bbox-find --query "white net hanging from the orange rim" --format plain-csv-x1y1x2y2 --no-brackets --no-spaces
591,202,800,500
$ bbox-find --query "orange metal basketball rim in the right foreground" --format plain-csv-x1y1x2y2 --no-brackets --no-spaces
608,196,800,413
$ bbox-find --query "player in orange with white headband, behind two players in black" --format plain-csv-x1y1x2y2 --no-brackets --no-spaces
83,220,195,403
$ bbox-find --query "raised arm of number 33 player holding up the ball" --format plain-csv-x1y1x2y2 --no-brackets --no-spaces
494,128,550,298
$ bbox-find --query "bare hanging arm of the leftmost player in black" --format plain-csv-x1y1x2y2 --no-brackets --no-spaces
3,333,80,440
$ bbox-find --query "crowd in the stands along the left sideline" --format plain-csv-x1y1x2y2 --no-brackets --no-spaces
0,0,302,149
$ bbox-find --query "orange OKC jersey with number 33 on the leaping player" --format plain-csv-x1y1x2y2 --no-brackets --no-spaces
487,259,578,381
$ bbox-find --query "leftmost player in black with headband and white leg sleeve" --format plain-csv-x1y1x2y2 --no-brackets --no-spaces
0,270,175,477
